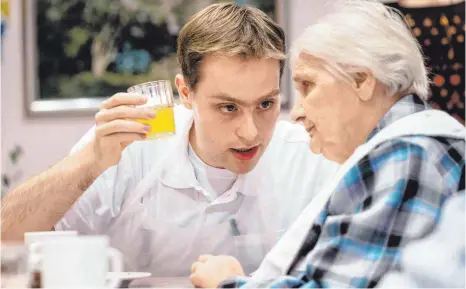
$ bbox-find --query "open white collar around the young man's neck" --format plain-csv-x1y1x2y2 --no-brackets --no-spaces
157,105,267,196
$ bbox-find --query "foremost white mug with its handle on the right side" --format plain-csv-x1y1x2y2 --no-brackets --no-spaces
41,236,123,289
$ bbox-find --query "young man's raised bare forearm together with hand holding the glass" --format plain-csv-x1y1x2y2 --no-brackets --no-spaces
1,93,155,241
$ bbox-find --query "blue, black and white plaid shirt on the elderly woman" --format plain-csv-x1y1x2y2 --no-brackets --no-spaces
220,95,465,288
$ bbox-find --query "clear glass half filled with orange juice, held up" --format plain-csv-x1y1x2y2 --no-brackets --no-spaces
128,80,176,139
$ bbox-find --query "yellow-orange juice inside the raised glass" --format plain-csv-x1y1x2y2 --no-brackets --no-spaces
138,106,175,139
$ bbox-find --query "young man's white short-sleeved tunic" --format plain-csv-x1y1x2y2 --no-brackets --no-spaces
55,106,338,276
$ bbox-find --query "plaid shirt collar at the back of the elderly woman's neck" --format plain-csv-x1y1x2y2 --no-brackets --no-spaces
366,94,431,142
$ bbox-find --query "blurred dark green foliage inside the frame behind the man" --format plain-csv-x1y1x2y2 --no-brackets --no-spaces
37,0,276,99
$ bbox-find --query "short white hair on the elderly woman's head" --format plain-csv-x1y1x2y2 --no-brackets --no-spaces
290,0,430,100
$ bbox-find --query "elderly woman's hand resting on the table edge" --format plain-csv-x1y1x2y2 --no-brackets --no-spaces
189,255,244,288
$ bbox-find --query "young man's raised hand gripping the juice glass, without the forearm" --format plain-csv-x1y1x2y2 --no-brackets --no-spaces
86,93,155,171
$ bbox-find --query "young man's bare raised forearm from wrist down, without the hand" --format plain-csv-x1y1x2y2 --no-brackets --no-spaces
1,145,103,240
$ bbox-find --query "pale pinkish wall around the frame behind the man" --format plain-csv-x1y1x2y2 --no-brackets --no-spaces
0,0,323,178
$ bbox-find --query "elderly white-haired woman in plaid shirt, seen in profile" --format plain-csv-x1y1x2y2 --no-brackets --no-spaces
191,0,465,288
